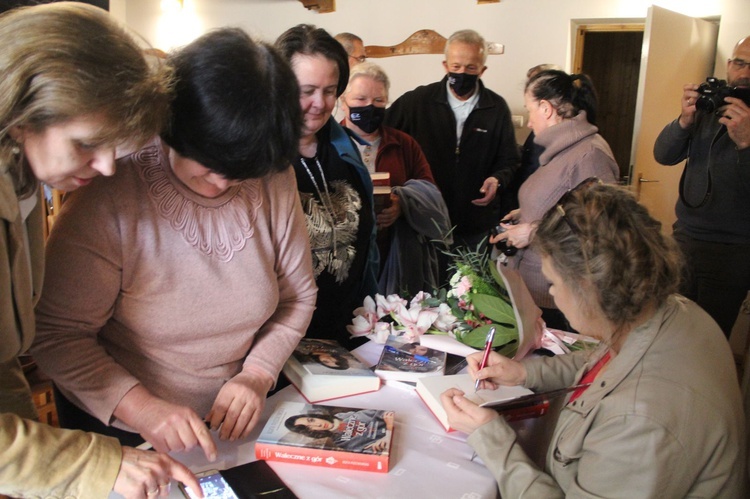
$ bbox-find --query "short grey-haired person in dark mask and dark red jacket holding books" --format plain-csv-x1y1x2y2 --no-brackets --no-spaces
341,62,451,296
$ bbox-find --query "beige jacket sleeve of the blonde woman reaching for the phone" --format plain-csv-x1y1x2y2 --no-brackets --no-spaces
0,414,122,499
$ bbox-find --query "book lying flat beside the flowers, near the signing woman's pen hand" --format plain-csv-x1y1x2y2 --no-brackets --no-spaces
375,335,447,381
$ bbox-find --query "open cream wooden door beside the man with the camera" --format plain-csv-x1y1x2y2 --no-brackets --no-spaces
630,6,723,233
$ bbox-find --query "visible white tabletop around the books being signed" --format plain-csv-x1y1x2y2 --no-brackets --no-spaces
160,342,512,499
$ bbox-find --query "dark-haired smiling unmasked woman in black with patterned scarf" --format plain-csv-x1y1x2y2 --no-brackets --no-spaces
276,24,379,347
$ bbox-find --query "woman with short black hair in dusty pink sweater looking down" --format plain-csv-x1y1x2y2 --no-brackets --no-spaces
32,29,316,460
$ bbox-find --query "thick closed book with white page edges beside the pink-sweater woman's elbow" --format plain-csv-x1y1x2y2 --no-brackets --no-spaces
282,338,380,403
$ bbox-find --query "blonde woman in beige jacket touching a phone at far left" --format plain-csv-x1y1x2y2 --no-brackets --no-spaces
0,2,203,498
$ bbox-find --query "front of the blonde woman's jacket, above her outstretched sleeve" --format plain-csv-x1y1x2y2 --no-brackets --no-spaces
0,167,44,417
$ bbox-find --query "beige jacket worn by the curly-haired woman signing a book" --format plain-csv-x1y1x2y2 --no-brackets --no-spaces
469,296,745,498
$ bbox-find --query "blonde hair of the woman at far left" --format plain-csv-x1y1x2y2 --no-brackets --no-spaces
0,2,170,195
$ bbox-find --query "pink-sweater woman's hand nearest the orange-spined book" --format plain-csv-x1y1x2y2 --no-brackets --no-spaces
206,372,273,441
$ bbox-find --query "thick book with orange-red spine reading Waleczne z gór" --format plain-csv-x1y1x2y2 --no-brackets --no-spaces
255,402,395,473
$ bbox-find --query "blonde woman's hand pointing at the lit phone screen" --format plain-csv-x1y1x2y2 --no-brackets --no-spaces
112,447,203,499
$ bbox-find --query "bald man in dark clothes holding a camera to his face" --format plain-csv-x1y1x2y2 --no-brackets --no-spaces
654,36,750,337
